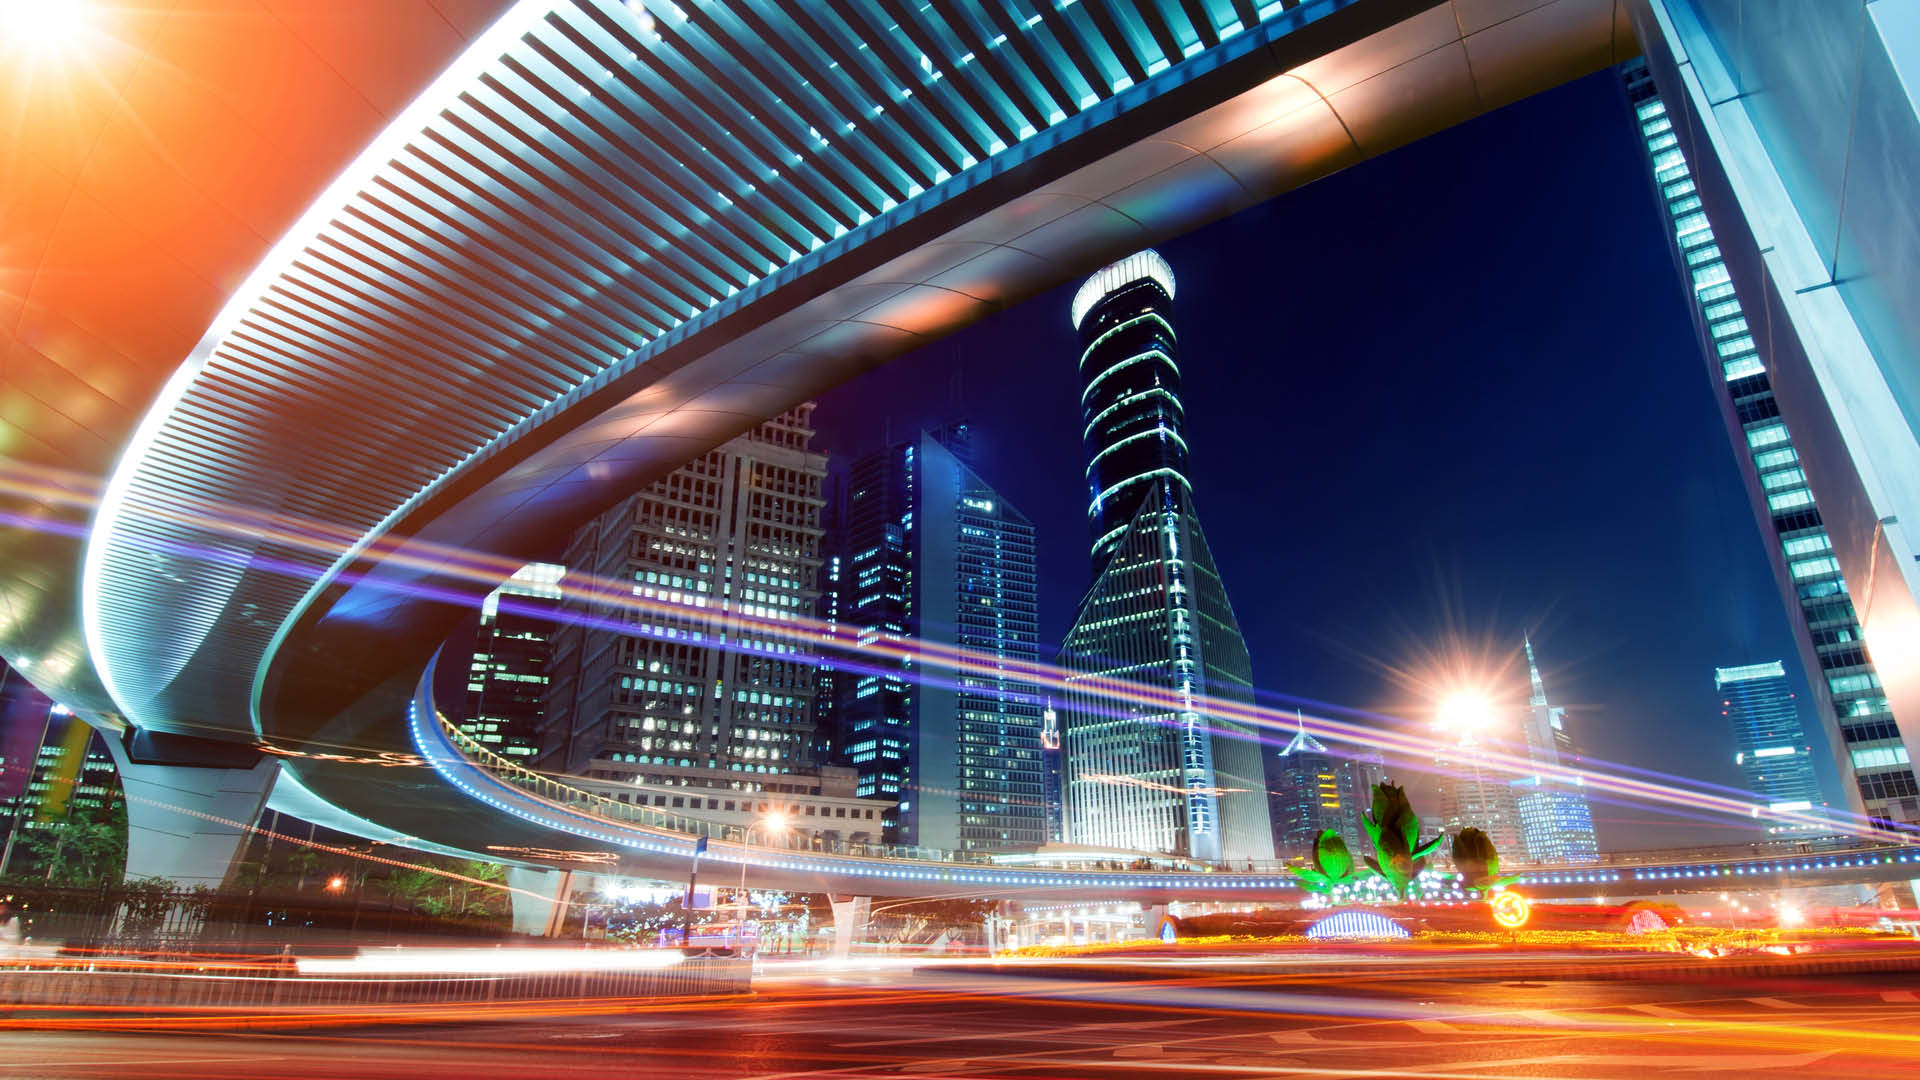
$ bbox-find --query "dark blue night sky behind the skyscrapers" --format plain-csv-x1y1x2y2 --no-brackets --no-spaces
816,71,1836,849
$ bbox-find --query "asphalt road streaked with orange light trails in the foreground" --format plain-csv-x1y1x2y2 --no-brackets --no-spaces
0,953,1920,1080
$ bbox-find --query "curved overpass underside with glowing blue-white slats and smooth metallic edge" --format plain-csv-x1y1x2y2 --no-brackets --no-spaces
8,0,1638,892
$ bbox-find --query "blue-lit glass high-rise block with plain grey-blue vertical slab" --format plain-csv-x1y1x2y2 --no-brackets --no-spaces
835,425,1046,851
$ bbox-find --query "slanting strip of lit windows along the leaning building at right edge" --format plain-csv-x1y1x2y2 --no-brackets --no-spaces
1622,60,1920,824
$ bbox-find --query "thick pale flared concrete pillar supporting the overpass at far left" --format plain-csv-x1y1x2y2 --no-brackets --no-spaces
104,734,280,888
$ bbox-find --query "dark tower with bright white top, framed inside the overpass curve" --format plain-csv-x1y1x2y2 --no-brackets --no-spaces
459,563,566,761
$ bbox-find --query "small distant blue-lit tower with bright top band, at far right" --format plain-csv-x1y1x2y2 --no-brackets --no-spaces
1713,659,1826,832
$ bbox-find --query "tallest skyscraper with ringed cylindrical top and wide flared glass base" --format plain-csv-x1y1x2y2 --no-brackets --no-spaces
1060,252,1273,861
